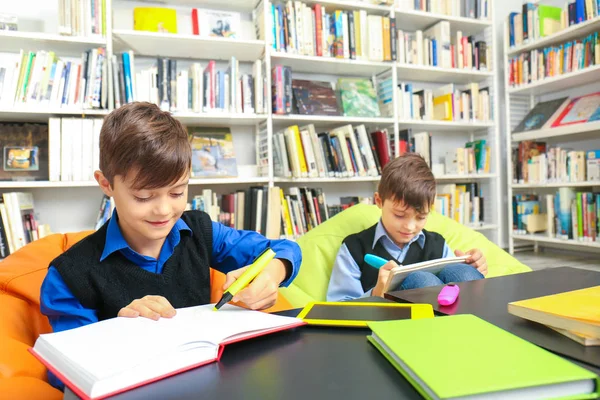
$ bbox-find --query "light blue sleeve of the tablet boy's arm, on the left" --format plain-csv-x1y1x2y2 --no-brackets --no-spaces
327,244,373,301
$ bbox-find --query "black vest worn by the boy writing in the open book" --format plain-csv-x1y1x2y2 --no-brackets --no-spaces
50,211,212,320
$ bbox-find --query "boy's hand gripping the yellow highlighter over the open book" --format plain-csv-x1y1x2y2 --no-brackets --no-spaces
223,258,287,310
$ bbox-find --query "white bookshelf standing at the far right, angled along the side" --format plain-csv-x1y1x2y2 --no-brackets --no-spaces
504,18,600,253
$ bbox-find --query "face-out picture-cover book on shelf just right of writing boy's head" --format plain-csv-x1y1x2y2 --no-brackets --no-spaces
187,126,238,178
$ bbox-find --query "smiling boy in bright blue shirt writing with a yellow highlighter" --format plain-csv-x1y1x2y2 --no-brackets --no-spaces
40,103,302,387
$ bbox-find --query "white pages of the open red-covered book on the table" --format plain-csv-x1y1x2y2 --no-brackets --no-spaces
34,304,299,381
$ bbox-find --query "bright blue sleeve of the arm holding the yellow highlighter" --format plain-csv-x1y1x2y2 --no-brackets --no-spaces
211,222,302,287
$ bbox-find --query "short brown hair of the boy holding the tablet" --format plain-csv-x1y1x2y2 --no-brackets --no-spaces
378,153,435,213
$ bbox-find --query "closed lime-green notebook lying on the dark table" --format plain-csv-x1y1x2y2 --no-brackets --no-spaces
368,315,600,400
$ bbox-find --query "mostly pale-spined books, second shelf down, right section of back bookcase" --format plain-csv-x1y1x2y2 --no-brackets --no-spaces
396,21,492,71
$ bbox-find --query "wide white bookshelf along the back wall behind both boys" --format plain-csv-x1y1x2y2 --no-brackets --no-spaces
0,0,502,240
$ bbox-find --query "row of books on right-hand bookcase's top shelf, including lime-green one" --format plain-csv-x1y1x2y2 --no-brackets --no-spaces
507,0,599,47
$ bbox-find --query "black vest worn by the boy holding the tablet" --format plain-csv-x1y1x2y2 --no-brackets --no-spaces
344,224,446,292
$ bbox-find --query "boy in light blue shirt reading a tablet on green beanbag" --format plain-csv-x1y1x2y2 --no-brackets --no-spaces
327,153,487,301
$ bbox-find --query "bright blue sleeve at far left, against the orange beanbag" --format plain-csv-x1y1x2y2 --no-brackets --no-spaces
40,266,98,390
